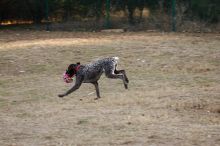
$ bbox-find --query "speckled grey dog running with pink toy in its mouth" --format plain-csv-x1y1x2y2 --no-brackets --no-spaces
58,57,129,99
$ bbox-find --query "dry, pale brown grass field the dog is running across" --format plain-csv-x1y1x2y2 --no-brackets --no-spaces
0,30,220,146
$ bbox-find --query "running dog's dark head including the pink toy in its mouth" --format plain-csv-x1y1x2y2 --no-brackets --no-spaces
63,62,80,83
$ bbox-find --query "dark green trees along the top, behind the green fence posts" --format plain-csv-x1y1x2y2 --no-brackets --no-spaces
0,0,220,24
